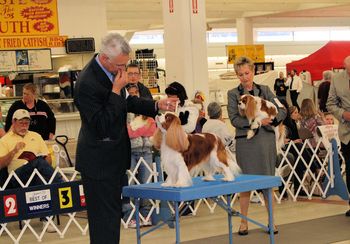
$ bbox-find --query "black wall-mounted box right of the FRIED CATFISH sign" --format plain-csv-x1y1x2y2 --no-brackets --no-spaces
65,37,95,53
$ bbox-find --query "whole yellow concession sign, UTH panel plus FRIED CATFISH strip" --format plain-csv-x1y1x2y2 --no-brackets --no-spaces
0,0,66,50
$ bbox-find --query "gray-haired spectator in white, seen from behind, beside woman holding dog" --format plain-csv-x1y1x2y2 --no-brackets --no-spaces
202,102,236,153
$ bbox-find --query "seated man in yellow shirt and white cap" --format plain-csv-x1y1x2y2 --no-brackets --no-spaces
0,109,63,232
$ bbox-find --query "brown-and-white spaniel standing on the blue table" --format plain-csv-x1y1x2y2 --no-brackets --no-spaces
153,112,240,187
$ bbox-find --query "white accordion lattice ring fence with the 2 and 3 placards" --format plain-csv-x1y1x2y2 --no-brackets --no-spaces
0,138,348,243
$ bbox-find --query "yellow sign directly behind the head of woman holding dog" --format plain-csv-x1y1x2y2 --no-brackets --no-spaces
226,45,265,64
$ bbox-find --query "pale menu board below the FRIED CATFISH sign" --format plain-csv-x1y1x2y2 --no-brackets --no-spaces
0,48,52,72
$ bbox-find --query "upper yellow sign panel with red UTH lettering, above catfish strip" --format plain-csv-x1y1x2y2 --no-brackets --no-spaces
0,0,59,37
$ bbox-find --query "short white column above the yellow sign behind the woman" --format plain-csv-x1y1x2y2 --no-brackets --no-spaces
236,18,254,45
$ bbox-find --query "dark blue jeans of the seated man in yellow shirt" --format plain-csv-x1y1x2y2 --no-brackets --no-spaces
10,157,63,188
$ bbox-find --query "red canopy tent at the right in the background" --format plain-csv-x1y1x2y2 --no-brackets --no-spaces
286,41,350,81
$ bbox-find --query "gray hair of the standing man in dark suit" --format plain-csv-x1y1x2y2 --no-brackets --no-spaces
100,32,131,58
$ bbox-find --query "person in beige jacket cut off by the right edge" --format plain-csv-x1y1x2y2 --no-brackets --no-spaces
327,56,350,217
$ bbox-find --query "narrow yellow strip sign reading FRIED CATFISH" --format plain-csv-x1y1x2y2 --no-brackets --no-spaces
0,35,68,50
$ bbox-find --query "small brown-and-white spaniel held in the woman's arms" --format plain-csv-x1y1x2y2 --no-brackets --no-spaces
238,95,286,153
